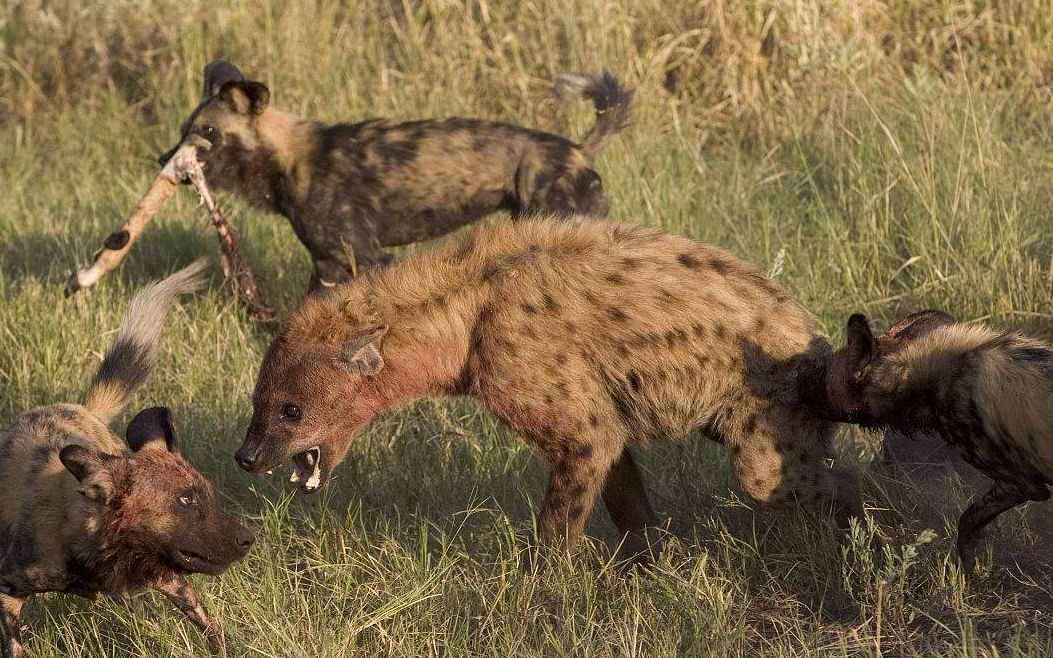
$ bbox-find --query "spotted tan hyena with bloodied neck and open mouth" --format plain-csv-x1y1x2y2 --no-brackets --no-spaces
235,219,861,554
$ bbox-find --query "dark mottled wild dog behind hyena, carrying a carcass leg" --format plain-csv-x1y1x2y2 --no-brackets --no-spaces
160,61,633,288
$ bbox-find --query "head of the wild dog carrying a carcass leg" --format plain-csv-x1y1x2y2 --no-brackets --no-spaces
158,60,271,187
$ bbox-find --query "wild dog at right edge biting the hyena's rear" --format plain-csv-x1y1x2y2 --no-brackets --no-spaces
799,311,1053,576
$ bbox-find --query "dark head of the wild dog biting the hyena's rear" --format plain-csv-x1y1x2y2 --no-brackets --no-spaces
799,310,954,425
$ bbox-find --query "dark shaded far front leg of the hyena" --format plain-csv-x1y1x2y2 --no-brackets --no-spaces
603,445,658,562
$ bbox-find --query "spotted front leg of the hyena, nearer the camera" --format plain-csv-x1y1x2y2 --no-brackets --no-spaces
538,437,623,553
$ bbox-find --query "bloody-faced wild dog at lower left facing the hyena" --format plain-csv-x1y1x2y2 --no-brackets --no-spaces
0,262,254,658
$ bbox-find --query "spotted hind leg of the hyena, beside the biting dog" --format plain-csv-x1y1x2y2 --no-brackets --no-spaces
721,405,862,527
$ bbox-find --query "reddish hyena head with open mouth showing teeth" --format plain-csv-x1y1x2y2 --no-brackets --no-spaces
234,313,388,493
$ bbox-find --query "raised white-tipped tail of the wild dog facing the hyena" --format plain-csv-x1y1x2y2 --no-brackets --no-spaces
84,259,207,424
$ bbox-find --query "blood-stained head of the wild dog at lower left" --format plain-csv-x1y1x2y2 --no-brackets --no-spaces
59,407,255,574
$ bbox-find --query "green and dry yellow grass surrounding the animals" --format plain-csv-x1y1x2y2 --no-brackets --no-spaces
0,0,1053,658
